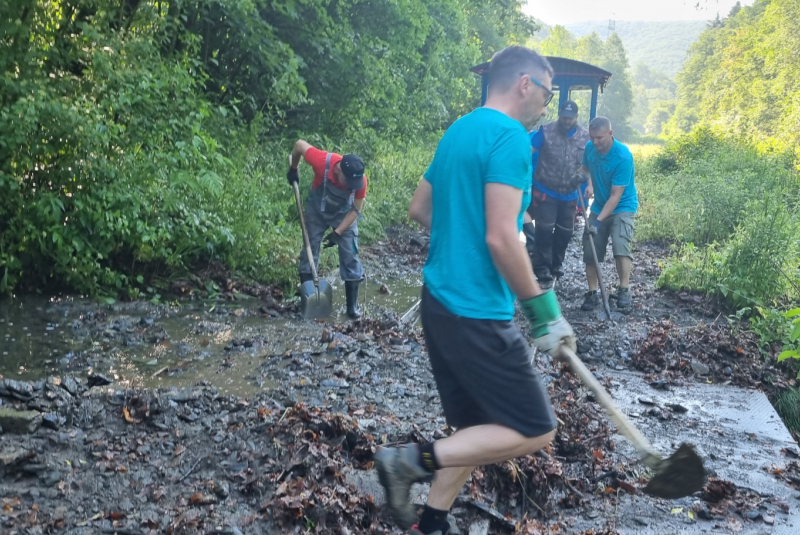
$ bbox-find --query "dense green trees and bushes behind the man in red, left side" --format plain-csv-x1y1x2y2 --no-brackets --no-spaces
0,0,536,297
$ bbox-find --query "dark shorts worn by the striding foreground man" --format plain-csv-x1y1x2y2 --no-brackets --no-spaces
421,287,556,437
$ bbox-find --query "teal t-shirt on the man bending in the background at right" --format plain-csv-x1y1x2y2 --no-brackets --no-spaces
583,139,639,215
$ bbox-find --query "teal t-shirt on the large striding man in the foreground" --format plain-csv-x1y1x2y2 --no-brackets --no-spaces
422,108,531,320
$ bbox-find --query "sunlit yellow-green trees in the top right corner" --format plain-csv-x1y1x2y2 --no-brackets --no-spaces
665,0,800,151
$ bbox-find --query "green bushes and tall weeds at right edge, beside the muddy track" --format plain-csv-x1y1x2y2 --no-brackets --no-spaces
637,129,800,307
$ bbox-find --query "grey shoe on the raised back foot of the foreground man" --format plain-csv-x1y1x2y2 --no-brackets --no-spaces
373,444,432,529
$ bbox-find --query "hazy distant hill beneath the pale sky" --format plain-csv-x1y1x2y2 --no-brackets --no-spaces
564,20,706,77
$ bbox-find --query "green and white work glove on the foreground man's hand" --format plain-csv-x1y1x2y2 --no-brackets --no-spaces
520,290,577,358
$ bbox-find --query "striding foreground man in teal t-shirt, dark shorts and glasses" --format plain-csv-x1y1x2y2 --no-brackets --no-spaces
375,46,575,535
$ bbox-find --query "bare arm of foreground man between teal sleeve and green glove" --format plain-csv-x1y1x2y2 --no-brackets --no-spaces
484,183,542,300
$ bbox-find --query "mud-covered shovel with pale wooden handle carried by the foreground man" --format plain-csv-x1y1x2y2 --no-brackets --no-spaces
560,346,706,500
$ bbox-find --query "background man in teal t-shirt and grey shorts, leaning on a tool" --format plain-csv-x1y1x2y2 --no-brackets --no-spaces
581,117,639,311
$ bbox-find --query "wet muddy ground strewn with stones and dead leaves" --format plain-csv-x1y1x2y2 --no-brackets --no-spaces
0,230,800,534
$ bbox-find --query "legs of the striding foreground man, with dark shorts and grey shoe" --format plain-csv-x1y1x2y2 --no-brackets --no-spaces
375,288,555,533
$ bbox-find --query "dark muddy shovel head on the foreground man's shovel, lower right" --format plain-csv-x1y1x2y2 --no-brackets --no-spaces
644,444,706,500
